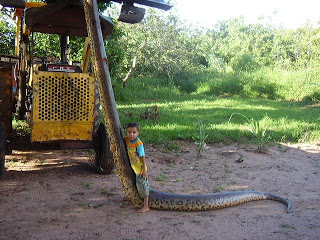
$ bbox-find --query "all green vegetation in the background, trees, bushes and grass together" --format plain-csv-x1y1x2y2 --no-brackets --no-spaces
0,5,320,145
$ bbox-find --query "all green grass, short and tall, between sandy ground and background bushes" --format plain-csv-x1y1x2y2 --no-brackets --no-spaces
13,69,320,147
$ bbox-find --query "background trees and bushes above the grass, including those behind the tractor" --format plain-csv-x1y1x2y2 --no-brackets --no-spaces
0,5,320,81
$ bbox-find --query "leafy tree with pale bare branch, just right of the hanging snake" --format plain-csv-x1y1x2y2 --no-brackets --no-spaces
110,9,206,84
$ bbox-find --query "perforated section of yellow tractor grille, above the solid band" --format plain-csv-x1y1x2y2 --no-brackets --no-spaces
37,73,93,121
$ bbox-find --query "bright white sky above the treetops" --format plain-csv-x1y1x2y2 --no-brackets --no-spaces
170,0,320,28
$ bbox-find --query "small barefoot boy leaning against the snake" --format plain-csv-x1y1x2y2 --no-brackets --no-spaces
110,122,150,213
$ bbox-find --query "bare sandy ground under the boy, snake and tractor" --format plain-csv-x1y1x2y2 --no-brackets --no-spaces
0,142,320,240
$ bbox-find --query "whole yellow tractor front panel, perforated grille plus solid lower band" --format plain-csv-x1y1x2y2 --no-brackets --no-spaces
31,71,95,142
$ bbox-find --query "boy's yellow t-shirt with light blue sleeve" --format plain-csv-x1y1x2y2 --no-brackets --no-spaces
125,137,145,175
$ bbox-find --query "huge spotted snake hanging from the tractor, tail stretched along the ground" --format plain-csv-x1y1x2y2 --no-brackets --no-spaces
83,0,291,212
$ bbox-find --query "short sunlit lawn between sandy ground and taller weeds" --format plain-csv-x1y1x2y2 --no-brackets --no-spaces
117,94,320,143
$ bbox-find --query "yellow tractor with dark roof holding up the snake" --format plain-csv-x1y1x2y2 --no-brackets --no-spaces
0,0,171,177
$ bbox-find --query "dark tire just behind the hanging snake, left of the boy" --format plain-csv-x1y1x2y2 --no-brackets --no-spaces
94,123,114,174
